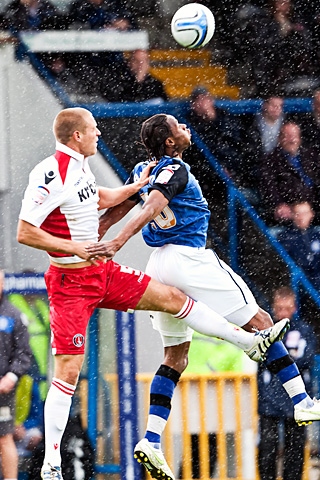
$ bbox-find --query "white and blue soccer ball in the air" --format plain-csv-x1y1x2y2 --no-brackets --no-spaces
171,3,215,48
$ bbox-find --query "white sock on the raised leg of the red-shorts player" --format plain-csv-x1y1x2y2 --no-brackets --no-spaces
174,297,254,350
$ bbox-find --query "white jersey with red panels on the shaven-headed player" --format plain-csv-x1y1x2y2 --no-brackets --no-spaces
19,142,99,263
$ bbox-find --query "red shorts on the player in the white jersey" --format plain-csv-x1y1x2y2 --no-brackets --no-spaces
45,260,151,355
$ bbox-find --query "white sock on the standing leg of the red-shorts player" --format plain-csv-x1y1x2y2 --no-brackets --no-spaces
43,378,76,467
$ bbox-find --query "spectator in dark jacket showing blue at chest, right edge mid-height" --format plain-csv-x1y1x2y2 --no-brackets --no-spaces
259,122,319,224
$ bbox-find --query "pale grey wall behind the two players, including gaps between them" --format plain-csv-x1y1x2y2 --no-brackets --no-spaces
0,45,162,372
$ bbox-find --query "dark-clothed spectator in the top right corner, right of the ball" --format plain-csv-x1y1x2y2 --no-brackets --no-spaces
234,0,316,96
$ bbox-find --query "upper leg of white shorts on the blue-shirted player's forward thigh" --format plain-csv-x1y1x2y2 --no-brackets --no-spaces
146,245,258,326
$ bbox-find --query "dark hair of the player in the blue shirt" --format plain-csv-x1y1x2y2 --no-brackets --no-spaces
140,113,171,160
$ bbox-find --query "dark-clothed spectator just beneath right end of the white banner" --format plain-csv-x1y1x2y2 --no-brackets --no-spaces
101,50,168,103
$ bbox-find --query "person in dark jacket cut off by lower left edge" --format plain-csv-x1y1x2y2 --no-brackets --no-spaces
0,270,32,480
